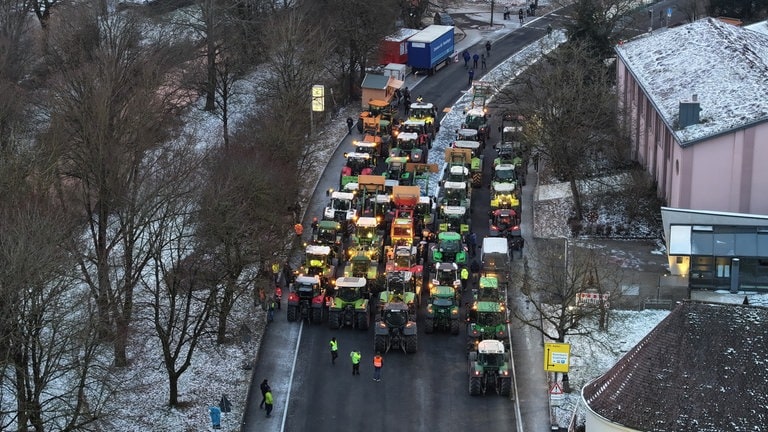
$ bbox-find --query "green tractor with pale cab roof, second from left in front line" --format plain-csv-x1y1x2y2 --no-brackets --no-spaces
328,277,371,330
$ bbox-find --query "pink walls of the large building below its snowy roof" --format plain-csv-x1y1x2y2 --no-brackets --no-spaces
616,59,768,214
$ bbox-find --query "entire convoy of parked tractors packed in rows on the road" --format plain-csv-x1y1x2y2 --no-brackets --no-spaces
288,88,521,396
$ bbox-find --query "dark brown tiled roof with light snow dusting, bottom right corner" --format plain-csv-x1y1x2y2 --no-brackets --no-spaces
582,302,768,432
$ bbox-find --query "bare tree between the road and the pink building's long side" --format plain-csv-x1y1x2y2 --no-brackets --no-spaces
498,42,628,220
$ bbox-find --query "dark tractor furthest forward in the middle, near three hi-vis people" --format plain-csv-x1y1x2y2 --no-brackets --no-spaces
373,302,418,354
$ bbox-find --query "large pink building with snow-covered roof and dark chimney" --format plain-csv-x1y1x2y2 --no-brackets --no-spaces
616,18,768,214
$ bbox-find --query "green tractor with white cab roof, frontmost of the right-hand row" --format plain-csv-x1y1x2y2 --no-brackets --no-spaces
469,339,512,396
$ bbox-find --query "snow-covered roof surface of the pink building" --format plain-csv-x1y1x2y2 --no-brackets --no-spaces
616,18,768,146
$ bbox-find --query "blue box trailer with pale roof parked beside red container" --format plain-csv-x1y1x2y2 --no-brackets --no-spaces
407,25,454,75
